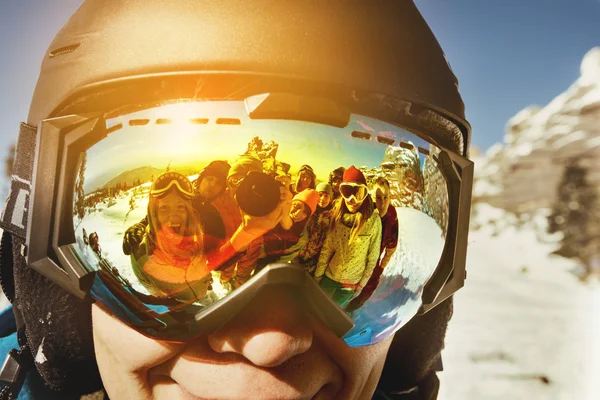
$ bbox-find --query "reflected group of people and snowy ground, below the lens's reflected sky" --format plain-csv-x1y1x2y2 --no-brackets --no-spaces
74,123,448,313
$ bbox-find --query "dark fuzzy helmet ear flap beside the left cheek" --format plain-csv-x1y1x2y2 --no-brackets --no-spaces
8,233,102,396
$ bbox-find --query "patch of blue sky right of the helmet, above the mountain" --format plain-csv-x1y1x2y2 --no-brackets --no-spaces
415,0,600,149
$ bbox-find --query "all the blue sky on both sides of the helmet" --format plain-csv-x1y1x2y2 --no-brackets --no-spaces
0,0,600,175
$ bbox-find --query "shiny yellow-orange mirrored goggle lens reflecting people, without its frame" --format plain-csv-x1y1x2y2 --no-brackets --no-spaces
72,97,449,346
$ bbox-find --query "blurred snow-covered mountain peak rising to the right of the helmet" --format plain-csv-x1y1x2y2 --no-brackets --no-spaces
473,47,600,213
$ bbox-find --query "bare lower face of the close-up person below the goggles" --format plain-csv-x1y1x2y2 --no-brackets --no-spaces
92,287,391,400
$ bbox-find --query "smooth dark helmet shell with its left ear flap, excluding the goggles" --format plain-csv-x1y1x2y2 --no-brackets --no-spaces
2,0,470,393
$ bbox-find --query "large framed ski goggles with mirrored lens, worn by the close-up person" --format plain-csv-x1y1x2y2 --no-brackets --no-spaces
3,94,473,347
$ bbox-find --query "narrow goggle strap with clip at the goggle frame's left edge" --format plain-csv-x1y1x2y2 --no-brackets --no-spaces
0,122,37,239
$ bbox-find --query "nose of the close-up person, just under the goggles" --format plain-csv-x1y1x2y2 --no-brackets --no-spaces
208,287,313,367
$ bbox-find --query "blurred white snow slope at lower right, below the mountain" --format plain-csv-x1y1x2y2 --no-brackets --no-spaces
439,206,600,400
